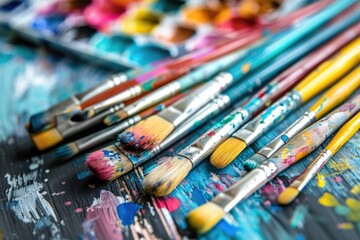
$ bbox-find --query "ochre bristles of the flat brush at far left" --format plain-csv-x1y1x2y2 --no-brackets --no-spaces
30,128,63,151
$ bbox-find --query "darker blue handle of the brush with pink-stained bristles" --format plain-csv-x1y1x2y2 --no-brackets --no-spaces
225,9,360,102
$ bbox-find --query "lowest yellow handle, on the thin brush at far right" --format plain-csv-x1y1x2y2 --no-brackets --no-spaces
326,112,360,155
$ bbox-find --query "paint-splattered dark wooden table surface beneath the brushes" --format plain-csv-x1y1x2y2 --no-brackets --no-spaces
0,37,360,239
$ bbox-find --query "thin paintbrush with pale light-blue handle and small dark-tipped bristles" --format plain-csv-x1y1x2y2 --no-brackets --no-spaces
104,41,261,125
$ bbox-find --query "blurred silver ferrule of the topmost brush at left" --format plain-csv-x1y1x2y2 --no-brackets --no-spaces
79,73,129,102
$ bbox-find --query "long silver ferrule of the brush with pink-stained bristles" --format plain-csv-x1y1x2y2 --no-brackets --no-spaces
152,94,230,158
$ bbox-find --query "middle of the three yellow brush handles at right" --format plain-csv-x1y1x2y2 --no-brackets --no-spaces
310,67,360,119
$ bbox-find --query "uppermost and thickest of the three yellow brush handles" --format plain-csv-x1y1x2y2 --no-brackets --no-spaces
294,37,360,102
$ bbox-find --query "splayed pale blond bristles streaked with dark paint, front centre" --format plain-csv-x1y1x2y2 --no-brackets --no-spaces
143,156,192,197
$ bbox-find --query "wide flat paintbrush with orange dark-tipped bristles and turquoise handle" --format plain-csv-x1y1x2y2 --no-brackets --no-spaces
116,1,351,149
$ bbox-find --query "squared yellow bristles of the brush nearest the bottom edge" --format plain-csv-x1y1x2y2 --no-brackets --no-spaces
187,202,225,233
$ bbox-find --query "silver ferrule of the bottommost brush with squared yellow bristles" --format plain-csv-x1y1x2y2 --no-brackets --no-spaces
212,161,277,212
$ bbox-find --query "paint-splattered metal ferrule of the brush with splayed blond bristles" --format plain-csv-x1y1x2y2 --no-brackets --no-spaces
178,107,250,166
